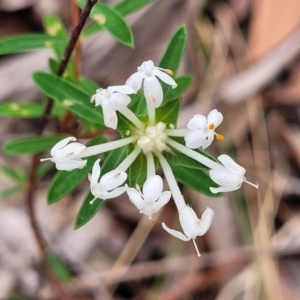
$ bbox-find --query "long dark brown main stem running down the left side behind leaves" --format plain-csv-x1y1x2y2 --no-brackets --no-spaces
25,0,97,299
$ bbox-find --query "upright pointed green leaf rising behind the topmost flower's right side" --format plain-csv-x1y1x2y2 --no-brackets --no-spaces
159,25,187,75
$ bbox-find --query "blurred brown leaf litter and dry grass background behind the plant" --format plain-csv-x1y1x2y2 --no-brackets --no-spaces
0,0,300,300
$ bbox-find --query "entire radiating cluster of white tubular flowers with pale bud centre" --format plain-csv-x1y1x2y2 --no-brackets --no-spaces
43,60,257,256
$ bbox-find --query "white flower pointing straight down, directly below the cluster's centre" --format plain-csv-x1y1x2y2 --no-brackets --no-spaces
127,175,171,219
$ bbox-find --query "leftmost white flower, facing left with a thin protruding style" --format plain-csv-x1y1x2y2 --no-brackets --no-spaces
41,137,87,171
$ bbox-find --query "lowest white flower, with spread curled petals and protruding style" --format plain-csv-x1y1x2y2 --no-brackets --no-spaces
162,205,214,256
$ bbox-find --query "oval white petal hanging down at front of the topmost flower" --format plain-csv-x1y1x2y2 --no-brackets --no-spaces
144,76,163,108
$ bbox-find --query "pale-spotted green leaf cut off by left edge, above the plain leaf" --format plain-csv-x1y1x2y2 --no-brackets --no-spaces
0,102,44,118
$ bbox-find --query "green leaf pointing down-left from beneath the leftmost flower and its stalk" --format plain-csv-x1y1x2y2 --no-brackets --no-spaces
47,137,105,204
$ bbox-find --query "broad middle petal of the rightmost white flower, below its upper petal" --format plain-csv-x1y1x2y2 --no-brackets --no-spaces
209,168,243,187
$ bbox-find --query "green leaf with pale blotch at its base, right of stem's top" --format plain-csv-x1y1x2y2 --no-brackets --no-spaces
91,3,134,47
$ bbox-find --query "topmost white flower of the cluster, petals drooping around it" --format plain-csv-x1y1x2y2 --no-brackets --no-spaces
126,60,177,107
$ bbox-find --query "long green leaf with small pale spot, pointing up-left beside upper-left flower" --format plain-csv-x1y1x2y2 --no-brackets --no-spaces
33,72,104,126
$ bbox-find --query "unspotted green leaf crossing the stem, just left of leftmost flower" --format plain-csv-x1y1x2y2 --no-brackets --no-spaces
3,135,66,155
